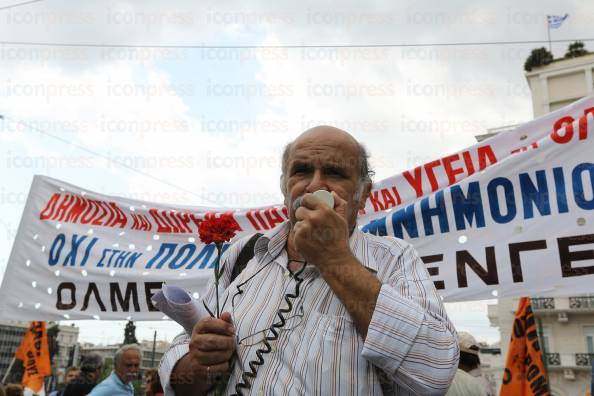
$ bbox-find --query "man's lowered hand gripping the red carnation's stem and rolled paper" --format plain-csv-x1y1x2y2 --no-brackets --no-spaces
172,312,235,396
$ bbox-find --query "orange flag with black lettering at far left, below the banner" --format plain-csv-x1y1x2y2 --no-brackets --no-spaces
15,322,52,394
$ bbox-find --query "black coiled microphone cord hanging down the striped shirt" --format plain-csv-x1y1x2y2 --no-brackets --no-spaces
233,263,306,396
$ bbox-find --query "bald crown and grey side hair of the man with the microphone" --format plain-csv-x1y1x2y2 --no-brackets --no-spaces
281,125,375,194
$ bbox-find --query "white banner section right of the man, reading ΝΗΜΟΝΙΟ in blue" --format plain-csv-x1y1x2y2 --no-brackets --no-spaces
363,97,594,301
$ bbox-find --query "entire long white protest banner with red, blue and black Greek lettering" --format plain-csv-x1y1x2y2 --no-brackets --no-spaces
0,96,594,320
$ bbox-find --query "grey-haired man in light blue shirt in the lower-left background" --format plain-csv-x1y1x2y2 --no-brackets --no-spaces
89,344,142,396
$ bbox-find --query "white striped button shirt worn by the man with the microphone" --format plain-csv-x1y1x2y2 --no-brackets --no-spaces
159,222,459,395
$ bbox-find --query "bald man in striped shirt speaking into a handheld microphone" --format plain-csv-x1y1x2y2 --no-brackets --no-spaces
160,126,459,396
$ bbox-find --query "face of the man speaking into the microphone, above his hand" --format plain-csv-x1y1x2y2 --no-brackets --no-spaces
285,134,366,230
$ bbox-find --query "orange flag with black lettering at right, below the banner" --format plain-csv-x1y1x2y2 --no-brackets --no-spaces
500,297,550,396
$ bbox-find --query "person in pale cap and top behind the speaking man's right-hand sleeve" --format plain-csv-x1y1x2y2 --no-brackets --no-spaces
447,331,495,396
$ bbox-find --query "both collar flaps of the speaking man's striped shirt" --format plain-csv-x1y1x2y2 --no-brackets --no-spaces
254,220,378,273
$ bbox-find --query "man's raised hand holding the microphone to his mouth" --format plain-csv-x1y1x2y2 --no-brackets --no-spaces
293,192,352,271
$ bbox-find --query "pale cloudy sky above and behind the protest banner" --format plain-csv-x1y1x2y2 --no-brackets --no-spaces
0,0,594,343
